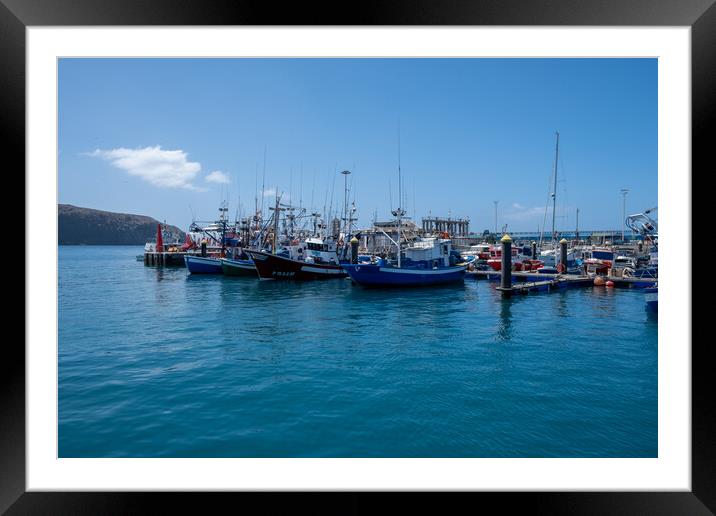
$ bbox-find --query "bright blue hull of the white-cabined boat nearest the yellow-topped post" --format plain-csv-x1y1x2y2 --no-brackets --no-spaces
345,264,467,287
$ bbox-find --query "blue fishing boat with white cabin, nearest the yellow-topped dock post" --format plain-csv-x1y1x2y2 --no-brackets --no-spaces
343,238,468,287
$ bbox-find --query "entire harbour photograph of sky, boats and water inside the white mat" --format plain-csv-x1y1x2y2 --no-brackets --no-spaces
56,57,660,464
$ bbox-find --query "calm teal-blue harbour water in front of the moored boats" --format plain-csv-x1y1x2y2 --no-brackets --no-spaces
59,246,657,457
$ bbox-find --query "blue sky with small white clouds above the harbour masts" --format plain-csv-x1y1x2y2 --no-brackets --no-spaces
58,59,658,231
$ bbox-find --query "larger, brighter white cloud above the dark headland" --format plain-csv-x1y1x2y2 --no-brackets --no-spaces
88,145,201,190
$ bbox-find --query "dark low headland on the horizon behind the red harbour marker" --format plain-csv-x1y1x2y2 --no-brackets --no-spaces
58,204,184,245
